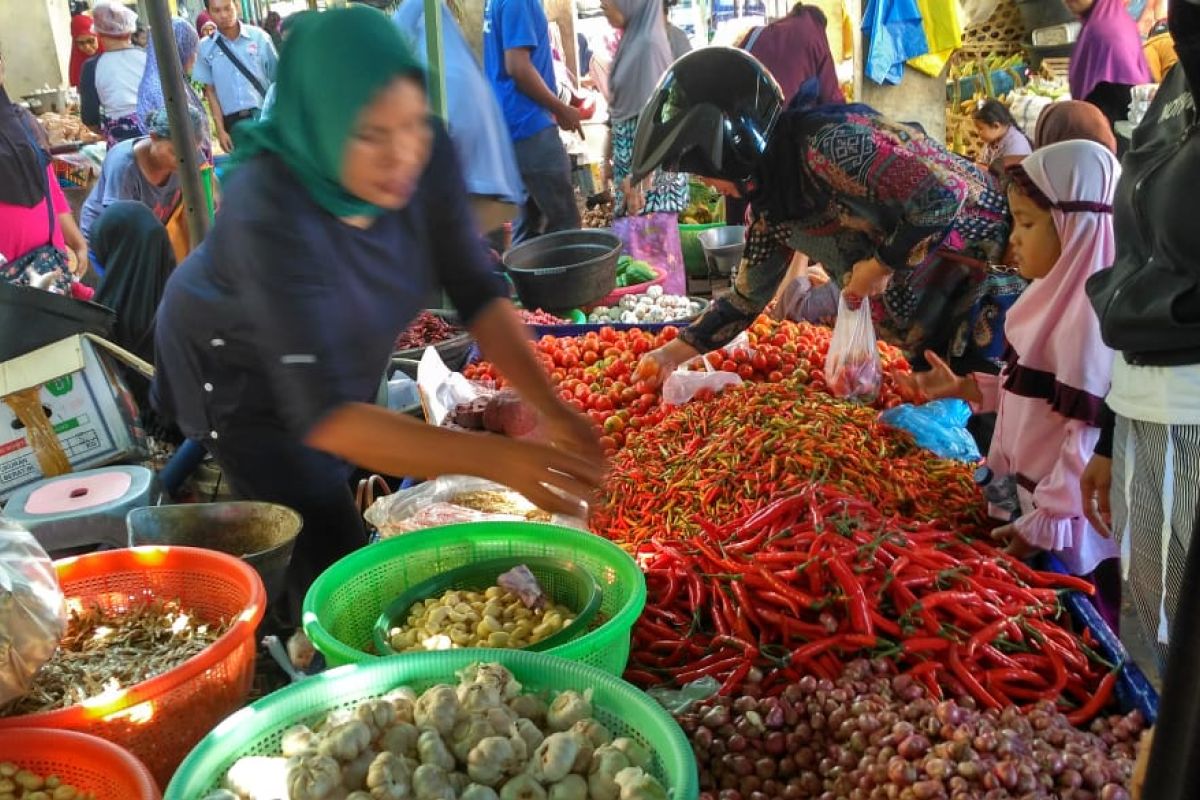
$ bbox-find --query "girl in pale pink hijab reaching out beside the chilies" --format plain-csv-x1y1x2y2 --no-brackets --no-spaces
916,140,1121,622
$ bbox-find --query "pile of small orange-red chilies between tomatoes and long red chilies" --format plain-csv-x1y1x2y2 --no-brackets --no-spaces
593,380,984,545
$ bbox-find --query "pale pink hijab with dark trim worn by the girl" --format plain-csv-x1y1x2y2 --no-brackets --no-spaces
1004,140,1121,425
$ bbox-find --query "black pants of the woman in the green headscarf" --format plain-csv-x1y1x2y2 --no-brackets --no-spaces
204,428,367,626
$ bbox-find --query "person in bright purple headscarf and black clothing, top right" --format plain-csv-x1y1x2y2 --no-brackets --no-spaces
1066,0,1152,122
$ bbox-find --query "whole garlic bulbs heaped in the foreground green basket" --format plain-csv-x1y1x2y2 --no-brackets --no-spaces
205,663,667,800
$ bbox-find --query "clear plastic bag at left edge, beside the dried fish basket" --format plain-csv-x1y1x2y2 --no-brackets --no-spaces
0,518,67,705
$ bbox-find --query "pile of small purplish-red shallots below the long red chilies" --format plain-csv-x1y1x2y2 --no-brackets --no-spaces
679,660,1144,800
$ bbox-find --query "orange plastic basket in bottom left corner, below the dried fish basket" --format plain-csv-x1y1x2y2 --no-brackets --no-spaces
0,728,162,800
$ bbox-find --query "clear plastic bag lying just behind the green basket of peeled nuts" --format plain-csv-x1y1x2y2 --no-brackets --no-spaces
362,475,587,539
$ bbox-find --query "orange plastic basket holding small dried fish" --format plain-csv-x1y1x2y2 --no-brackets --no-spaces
0,547,266,786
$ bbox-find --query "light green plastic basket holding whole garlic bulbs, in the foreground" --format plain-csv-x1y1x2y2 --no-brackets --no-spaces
163,650,700,800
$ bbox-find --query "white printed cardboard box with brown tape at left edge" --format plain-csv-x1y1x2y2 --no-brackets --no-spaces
0,335,146,501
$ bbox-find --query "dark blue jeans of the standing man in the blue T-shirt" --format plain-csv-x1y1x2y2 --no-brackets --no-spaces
512,125,582,245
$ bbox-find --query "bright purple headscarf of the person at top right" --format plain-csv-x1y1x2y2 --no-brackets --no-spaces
1067,0,1152,100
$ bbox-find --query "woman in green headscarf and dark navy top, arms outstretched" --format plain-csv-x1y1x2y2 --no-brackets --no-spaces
154,6,602,621
